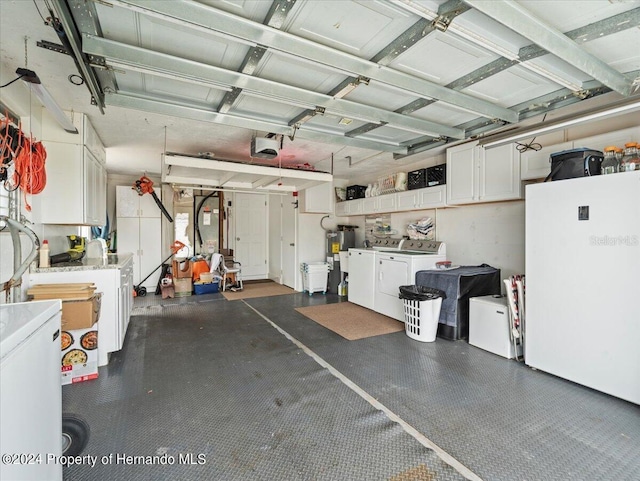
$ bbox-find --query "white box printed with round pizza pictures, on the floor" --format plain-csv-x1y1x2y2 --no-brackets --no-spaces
60,324,98,386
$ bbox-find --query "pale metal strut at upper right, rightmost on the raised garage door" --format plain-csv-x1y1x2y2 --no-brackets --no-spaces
465,0,631,96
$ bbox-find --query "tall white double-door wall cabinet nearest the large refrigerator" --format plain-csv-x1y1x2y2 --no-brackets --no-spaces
447,141,522,205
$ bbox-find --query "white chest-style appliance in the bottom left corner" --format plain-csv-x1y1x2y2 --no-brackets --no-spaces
0,300,62,481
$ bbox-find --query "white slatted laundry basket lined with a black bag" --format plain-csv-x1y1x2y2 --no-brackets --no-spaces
400,285,447,342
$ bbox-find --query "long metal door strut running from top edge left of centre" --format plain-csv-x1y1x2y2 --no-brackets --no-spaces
102,0,517,122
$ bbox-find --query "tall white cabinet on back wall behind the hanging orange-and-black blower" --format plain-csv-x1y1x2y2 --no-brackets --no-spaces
116,185,162,290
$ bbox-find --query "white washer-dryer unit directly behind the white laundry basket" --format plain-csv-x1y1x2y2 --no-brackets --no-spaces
374,239,447,322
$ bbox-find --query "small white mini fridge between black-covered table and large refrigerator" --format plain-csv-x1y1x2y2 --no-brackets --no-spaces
469,295,522,359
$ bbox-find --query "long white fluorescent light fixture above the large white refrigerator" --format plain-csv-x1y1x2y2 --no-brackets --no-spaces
479,97,640,148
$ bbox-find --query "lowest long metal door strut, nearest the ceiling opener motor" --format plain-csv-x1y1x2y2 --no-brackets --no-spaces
105,93,407,154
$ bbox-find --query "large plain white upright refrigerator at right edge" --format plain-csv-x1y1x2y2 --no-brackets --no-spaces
525,171,640,404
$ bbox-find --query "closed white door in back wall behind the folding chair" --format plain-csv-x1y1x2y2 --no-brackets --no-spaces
234,193,268,279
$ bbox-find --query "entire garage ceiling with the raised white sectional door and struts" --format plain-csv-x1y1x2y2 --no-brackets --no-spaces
0,0,640,184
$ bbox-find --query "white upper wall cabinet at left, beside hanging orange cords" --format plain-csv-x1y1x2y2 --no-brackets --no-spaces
33,110,107,226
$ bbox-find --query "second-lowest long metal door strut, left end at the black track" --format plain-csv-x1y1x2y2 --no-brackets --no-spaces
83,35,464,139
